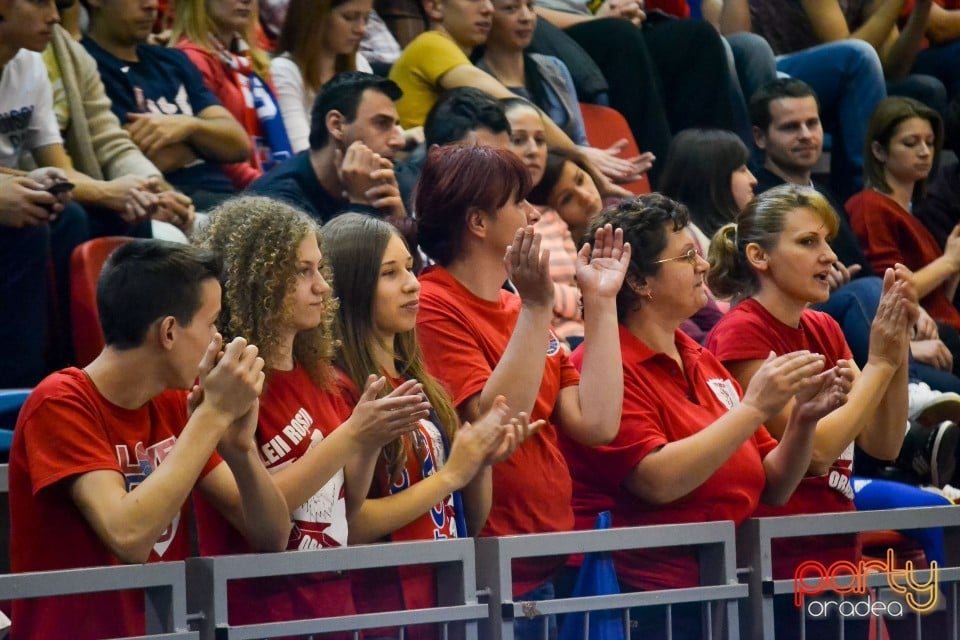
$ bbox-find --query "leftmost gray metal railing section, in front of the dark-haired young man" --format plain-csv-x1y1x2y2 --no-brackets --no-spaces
0,562,198,640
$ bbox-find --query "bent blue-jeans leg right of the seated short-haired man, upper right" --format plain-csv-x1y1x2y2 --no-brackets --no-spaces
777,40,887,202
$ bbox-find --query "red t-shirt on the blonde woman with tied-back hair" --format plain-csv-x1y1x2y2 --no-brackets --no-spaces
707,299,860,579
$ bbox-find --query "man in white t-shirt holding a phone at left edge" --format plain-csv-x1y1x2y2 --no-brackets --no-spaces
0,0,81,387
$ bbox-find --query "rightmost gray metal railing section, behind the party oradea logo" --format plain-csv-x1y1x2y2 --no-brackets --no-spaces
737,506,960,640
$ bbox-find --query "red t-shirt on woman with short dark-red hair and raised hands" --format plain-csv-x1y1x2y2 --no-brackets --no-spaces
417,266,580,595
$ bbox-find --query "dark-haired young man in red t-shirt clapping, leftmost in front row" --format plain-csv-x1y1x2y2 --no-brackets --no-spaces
10,240,290,639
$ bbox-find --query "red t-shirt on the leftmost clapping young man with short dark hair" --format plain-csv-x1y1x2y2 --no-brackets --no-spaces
10,368,221,640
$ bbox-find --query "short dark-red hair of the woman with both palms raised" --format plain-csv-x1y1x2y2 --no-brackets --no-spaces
414,145,530,266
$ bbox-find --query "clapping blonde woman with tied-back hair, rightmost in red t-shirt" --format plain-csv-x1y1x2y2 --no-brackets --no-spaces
707,185,919,638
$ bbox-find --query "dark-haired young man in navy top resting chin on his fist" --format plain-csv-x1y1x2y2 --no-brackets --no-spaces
247,71,407,224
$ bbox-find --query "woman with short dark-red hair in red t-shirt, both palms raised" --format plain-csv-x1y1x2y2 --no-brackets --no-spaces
414,147,630,637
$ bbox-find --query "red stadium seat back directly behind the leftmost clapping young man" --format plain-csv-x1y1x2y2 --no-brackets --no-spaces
70,237,131,367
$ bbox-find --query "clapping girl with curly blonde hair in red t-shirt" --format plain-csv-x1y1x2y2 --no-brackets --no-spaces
197,197,428,639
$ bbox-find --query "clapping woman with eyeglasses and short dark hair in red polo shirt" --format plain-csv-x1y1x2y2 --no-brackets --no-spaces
561,194,849,638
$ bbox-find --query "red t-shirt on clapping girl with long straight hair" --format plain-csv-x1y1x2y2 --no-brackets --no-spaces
345,380,466,640
